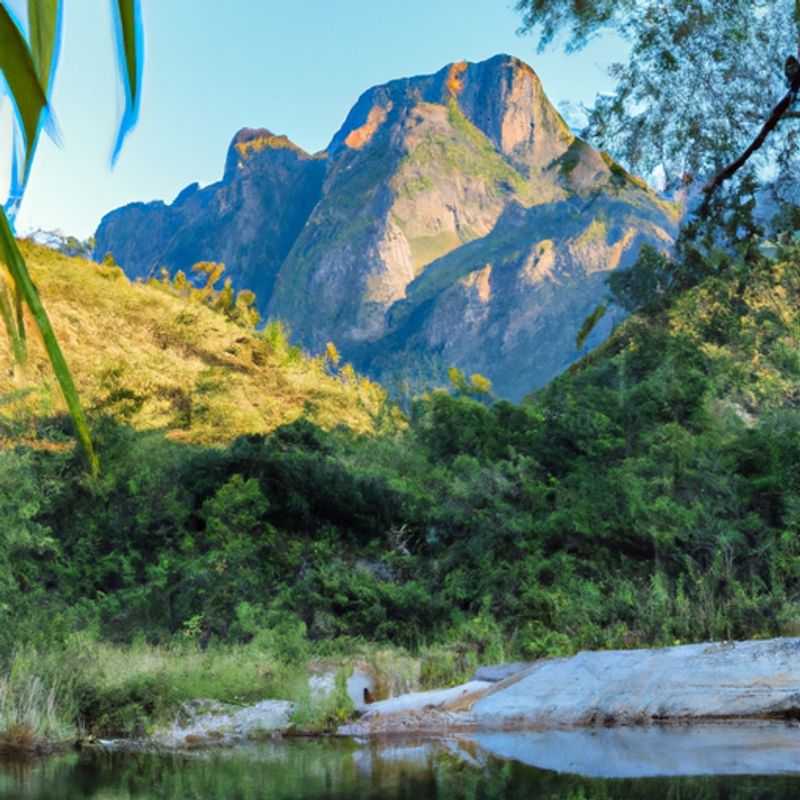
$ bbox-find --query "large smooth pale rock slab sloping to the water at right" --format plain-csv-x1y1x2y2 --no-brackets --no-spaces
342,638,800,734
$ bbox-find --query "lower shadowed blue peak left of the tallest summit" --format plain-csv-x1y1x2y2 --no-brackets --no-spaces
95,128,326,298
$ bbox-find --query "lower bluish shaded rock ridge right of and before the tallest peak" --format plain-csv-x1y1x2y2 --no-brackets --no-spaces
368,196,673,400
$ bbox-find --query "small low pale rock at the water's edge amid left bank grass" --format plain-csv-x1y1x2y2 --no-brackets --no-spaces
153,700,294,748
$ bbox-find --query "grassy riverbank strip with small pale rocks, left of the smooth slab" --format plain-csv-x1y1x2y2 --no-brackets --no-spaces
0,623,482,754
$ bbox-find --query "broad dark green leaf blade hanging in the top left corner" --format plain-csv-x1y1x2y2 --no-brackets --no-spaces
0,3,47,188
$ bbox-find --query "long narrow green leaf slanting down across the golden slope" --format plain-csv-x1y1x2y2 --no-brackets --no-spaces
0,208,100,476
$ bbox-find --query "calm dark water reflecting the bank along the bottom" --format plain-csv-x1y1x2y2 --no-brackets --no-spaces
0,726,800,800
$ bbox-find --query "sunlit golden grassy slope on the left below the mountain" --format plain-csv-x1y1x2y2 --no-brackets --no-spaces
0,242,394,442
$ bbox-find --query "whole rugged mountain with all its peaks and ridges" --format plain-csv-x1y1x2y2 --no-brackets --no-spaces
96,55,677,398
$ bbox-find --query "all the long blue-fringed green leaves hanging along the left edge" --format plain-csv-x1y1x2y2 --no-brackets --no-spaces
0,0,142,474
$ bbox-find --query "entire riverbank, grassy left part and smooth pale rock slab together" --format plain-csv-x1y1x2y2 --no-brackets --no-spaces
6,638,800,753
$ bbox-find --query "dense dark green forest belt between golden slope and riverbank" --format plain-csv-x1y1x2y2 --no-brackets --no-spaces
0,228,800,740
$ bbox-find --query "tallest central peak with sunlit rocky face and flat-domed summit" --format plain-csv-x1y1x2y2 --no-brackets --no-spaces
269,56,573,350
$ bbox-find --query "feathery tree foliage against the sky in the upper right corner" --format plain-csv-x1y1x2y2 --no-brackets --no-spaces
517,0,800,216
